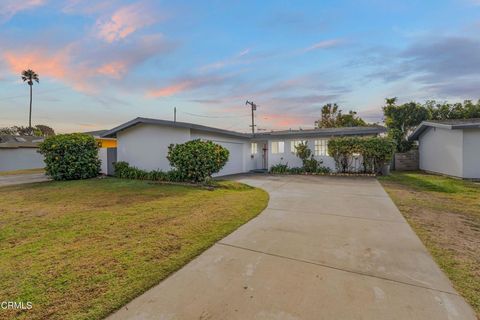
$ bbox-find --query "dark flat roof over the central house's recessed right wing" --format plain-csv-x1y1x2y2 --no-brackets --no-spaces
255,125,387,138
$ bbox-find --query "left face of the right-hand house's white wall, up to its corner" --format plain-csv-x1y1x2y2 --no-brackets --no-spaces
418,128,463,177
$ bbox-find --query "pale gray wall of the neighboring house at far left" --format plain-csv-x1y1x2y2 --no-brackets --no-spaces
0,148,45,171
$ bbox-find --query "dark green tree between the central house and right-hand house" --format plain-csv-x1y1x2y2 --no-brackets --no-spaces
383,98,430,152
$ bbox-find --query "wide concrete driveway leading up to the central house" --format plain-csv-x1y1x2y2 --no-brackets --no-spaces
110,175,476,320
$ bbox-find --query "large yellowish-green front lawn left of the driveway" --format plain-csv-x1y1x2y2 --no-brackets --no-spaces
0,178,268,319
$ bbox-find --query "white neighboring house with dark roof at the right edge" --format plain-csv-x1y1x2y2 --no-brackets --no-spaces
409,119,480,179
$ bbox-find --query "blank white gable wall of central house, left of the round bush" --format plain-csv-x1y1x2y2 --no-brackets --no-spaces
117,124,190,171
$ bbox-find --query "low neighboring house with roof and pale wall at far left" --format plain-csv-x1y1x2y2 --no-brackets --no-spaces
0,135,45,171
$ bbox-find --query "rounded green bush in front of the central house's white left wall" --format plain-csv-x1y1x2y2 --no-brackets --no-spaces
167,139,229,182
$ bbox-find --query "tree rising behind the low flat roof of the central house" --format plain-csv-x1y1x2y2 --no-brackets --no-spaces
315,103,367,128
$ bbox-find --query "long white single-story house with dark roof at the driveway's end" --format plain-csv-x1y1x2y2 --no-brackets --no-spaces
102,118,386,175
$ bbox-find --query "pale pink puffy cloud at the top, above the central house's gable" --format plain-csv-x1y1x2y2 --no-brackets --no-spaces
97,3,157,43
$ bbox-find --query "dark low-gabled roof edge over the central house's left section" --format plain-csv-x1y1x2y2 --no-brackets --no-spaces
101,118,250,138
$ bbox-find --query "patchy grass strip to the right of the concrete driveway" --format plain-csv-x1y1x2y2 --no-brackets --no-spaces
379,172,480,319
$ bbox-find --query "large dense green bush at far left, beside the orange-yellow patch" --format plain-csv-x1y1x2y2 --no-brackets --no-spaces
38,133,100,180
